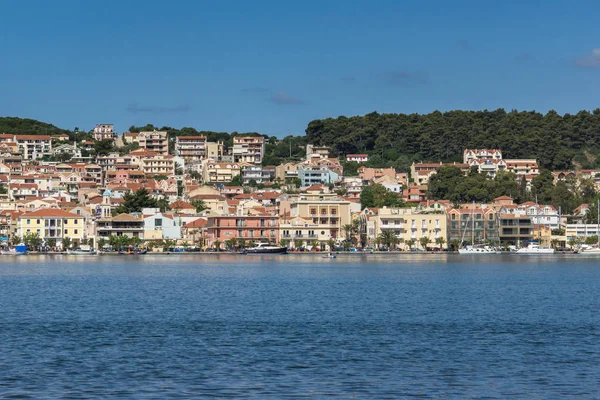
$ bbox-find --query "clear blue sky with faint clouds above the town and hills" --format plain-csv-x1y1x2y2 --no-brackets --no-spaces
0,0,600,136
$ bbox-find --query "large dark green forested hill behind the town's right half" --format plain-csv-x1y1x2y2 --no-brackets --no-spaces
306,109,600,170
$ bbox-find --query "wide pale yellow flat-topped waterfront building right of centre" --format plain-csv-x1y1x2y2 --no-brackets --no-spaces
375,207,448,249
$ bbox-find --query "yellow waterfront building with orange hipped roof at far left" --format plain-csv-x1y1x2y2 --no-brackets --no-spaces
17,208,85,247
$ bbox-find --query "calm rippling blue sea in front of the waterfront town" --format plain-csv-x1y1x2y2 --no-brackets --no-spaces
0,255,600,399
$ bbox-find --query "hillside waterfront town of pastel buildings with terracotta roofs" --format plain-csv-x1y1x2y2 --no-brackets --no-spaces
0,124,600,252
